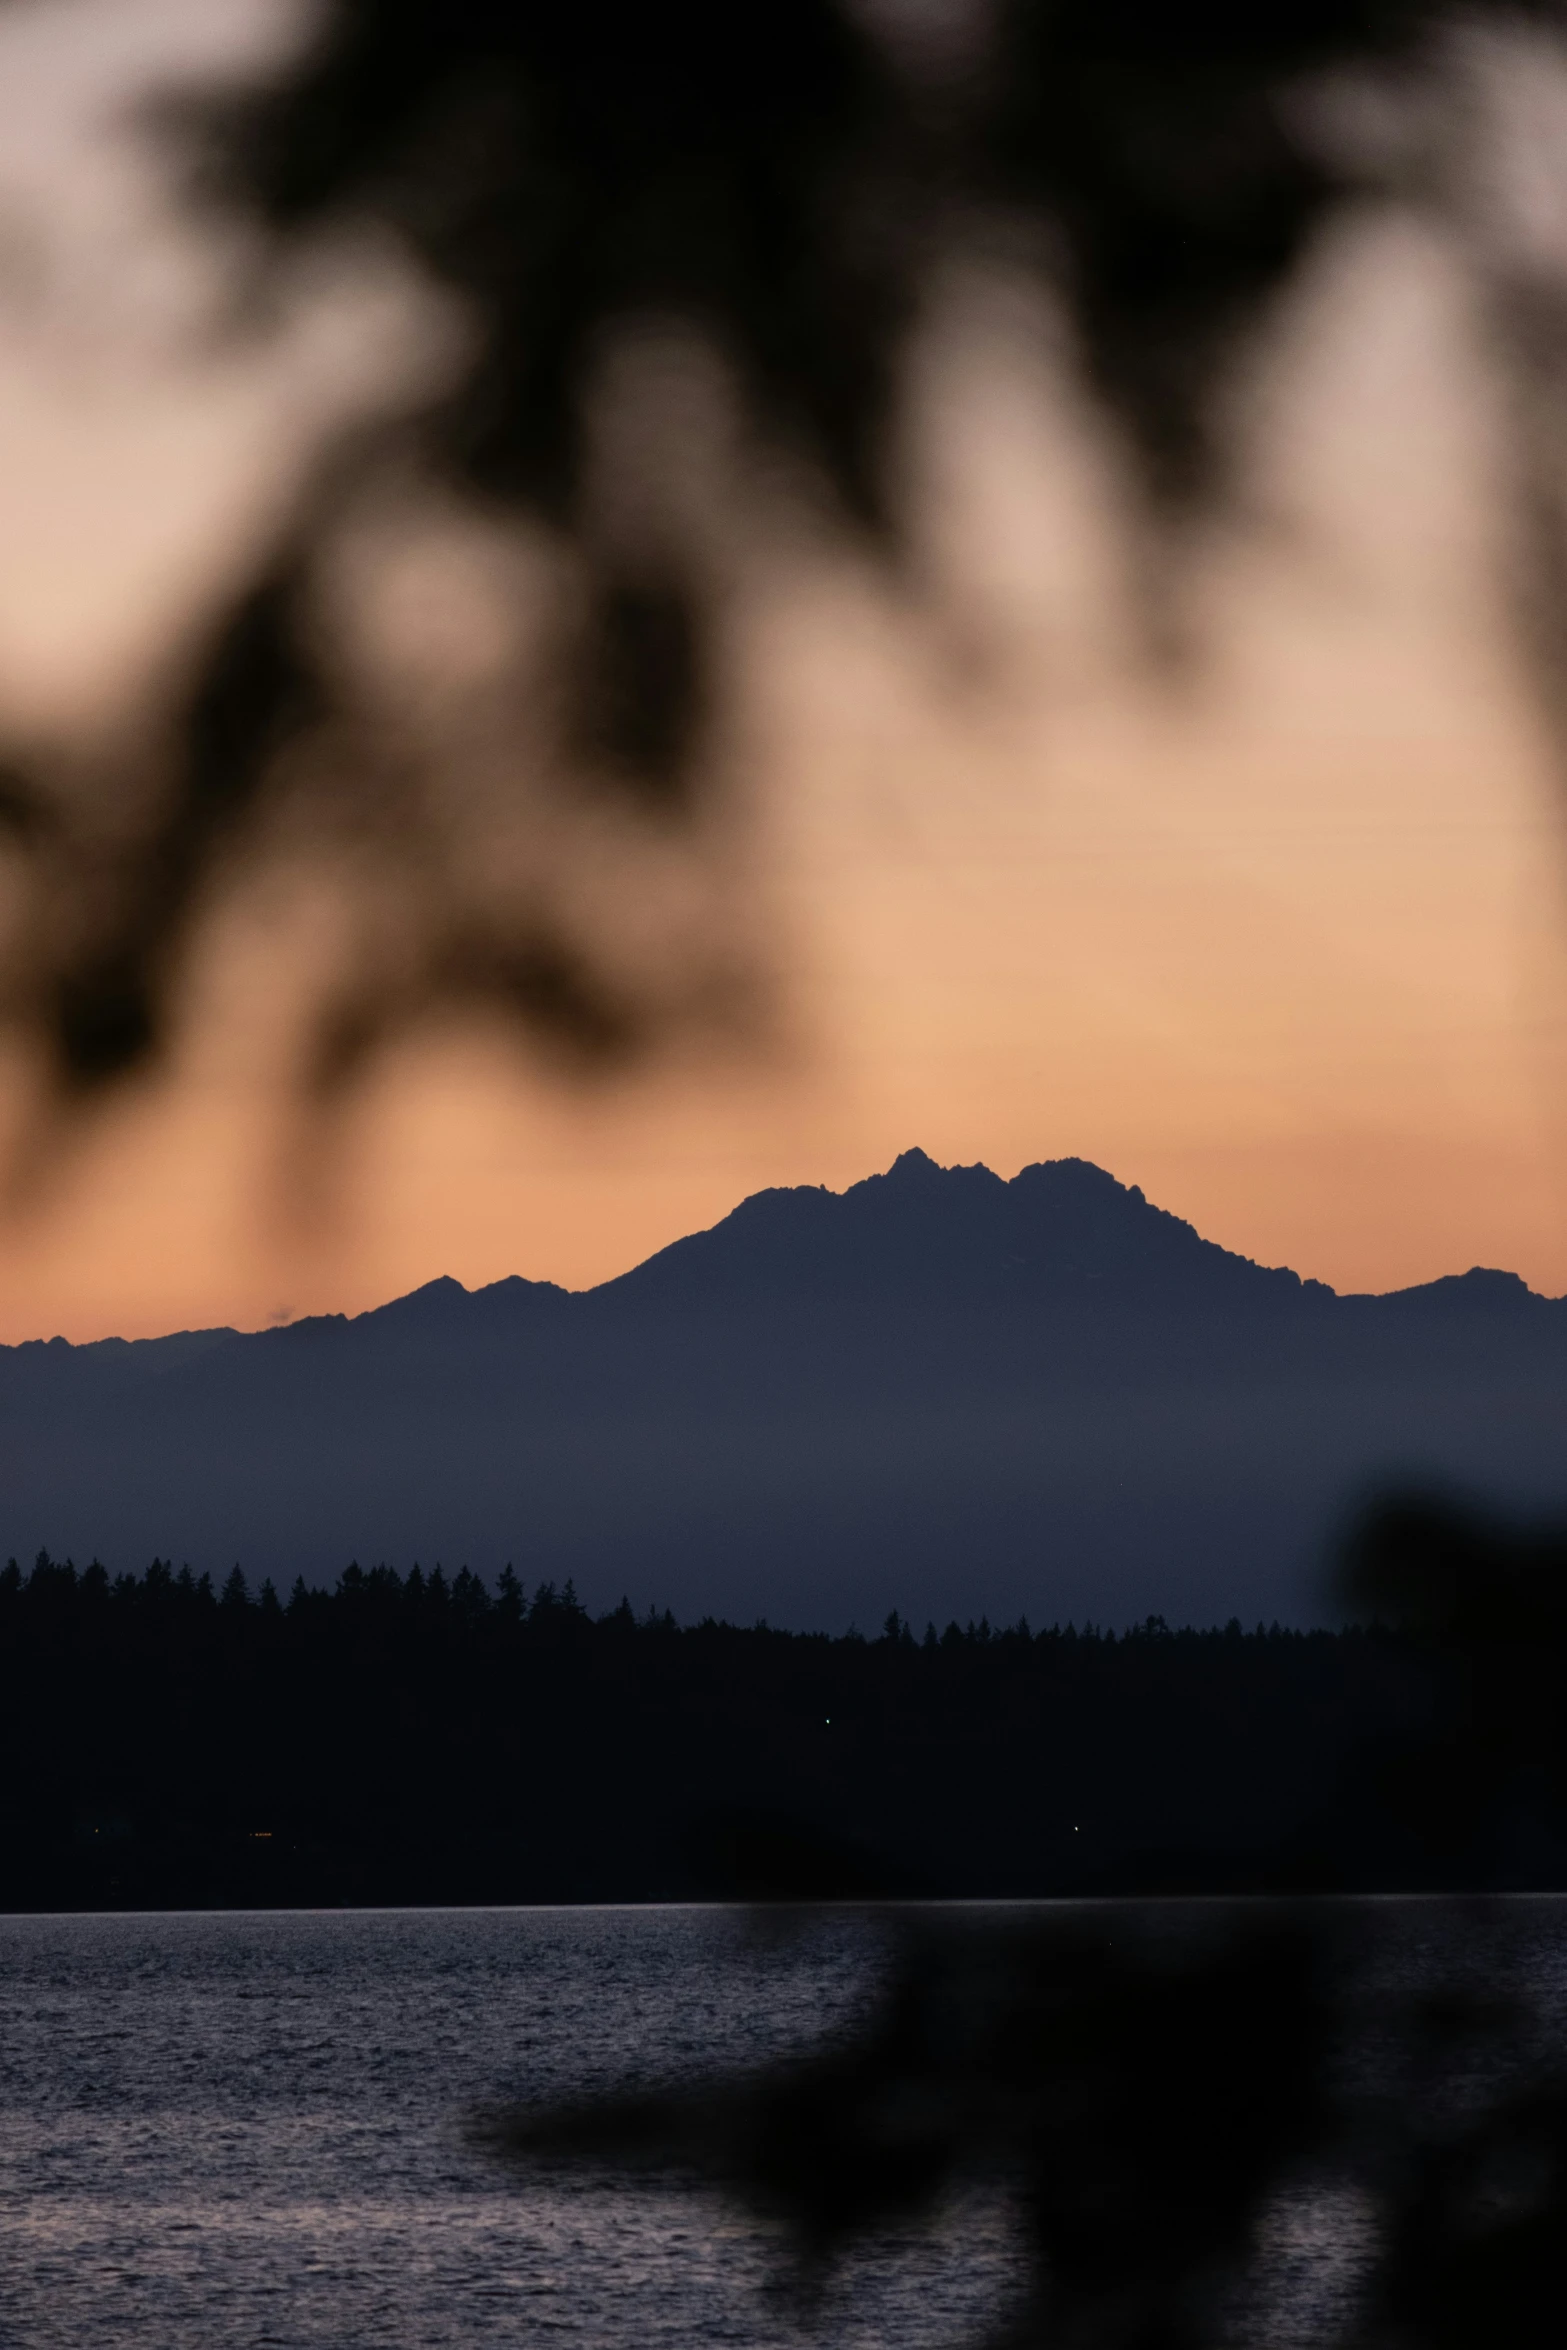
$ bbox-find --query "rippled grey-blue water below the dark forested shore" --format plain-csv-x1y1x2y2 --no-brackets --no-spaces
0,1901,1567,2350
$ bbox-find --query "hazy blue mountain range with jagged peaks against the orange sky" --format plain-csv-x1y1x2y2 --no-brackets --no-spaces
0,1152,1567,1629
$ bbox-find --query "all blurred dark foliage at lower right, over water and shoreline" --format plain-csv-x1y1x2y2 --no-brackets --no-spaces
493,1506,1567,2350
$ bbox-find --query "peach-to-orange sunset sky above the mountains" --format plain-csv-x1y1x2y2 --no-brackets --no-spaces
0,0,1567,1340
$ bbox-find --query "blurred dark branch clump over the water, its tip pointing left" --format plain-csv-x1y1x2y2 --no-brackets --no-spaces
493,1922,1323,2343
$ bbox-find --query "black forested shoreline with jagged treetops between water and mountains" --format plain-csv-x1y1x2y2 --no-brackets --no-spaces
0,1553,1494,1908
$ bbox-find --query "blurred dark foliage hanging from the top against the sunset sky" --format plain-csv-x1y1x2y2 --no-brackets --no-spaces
7,0,1558,1090
